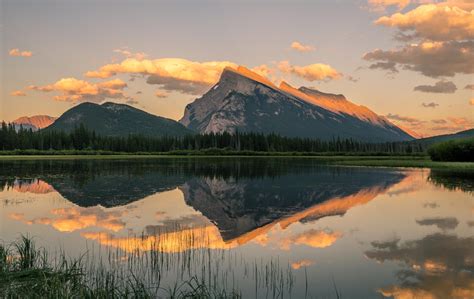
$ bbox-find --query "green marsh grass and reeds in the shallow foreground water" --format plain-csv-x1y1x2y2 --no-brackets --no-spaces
0,236,300,298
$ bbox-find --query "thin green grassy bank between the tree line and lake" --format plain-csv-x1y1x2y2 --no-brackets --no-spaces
0,151,474,171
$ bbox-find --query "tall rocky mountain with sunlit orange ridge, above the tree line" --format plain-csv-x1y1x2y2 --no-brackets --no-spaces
180,67,413,142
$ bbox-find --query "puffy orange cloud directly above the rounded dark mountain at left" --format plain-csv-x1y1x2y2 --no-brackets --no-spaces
28,78,127,102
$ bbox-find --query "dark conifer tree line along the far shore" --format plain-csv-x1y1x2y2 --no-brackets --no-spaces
0,123,426,154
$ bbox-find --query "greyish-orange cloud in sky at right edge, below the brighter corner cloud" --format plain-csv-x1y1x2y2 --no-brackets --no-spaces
363,41,474,78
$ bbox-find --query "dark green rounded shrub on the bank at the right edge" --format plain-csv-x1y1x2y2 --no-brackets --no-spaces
428,138,474,162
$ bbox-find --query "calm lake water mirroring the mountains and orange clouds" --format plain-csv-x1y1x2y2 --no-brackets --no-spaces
0,158,474,298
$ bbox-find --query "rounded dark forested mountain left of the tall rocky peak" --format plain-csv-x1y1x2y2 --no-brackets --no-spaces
46,102,193,137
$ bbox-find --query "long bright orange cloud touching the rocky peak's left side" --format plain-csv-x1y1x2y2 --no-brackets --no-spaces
85,58,237,94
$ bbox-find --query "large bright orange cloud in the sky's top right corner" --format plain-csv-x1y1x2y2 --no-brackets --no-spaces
375,1,474,41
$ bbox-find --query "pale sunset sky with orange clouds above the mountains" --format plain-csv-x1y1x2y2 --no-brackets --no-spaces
0,0,474,136
